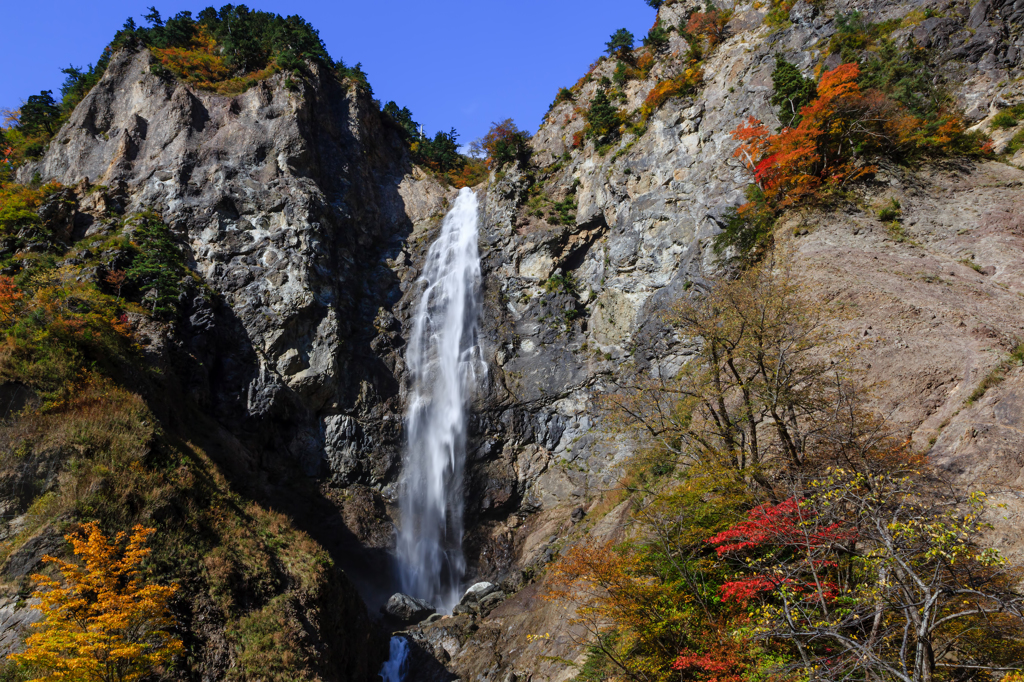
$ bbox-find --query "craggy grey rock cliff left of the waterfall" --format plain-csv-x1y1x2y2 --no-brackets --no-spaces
22,45,443,484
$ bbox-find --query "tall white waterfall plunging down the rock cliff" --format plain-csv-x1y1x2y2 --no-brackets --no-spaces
397,188,486,611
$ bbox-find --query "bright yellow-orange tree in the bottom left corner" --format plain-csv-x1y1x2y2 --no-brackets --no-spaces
10,522,182,682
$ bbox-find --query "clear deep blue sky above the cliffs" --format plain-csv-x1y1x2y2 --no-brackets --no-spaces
0,0,654,143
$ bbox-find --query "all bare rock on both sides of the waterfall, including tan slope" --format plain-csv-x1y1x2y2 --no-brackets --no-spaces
5,0,1024,680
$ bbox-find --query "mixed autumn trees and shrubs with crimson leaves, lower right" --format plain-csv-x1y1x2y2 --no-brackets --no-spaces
549,253,1024,682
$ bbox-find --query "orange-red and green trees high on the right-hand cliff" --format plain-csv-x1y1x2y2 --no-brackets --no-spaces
715,12,991,259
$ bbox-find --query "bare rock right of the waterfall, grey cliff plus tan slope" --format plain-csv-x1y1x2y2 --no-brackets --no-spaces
382,2,1024,680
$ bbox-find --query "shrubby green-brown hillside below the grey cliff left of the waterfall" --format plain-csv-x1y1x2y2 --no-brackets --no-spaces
0,164,368,680
